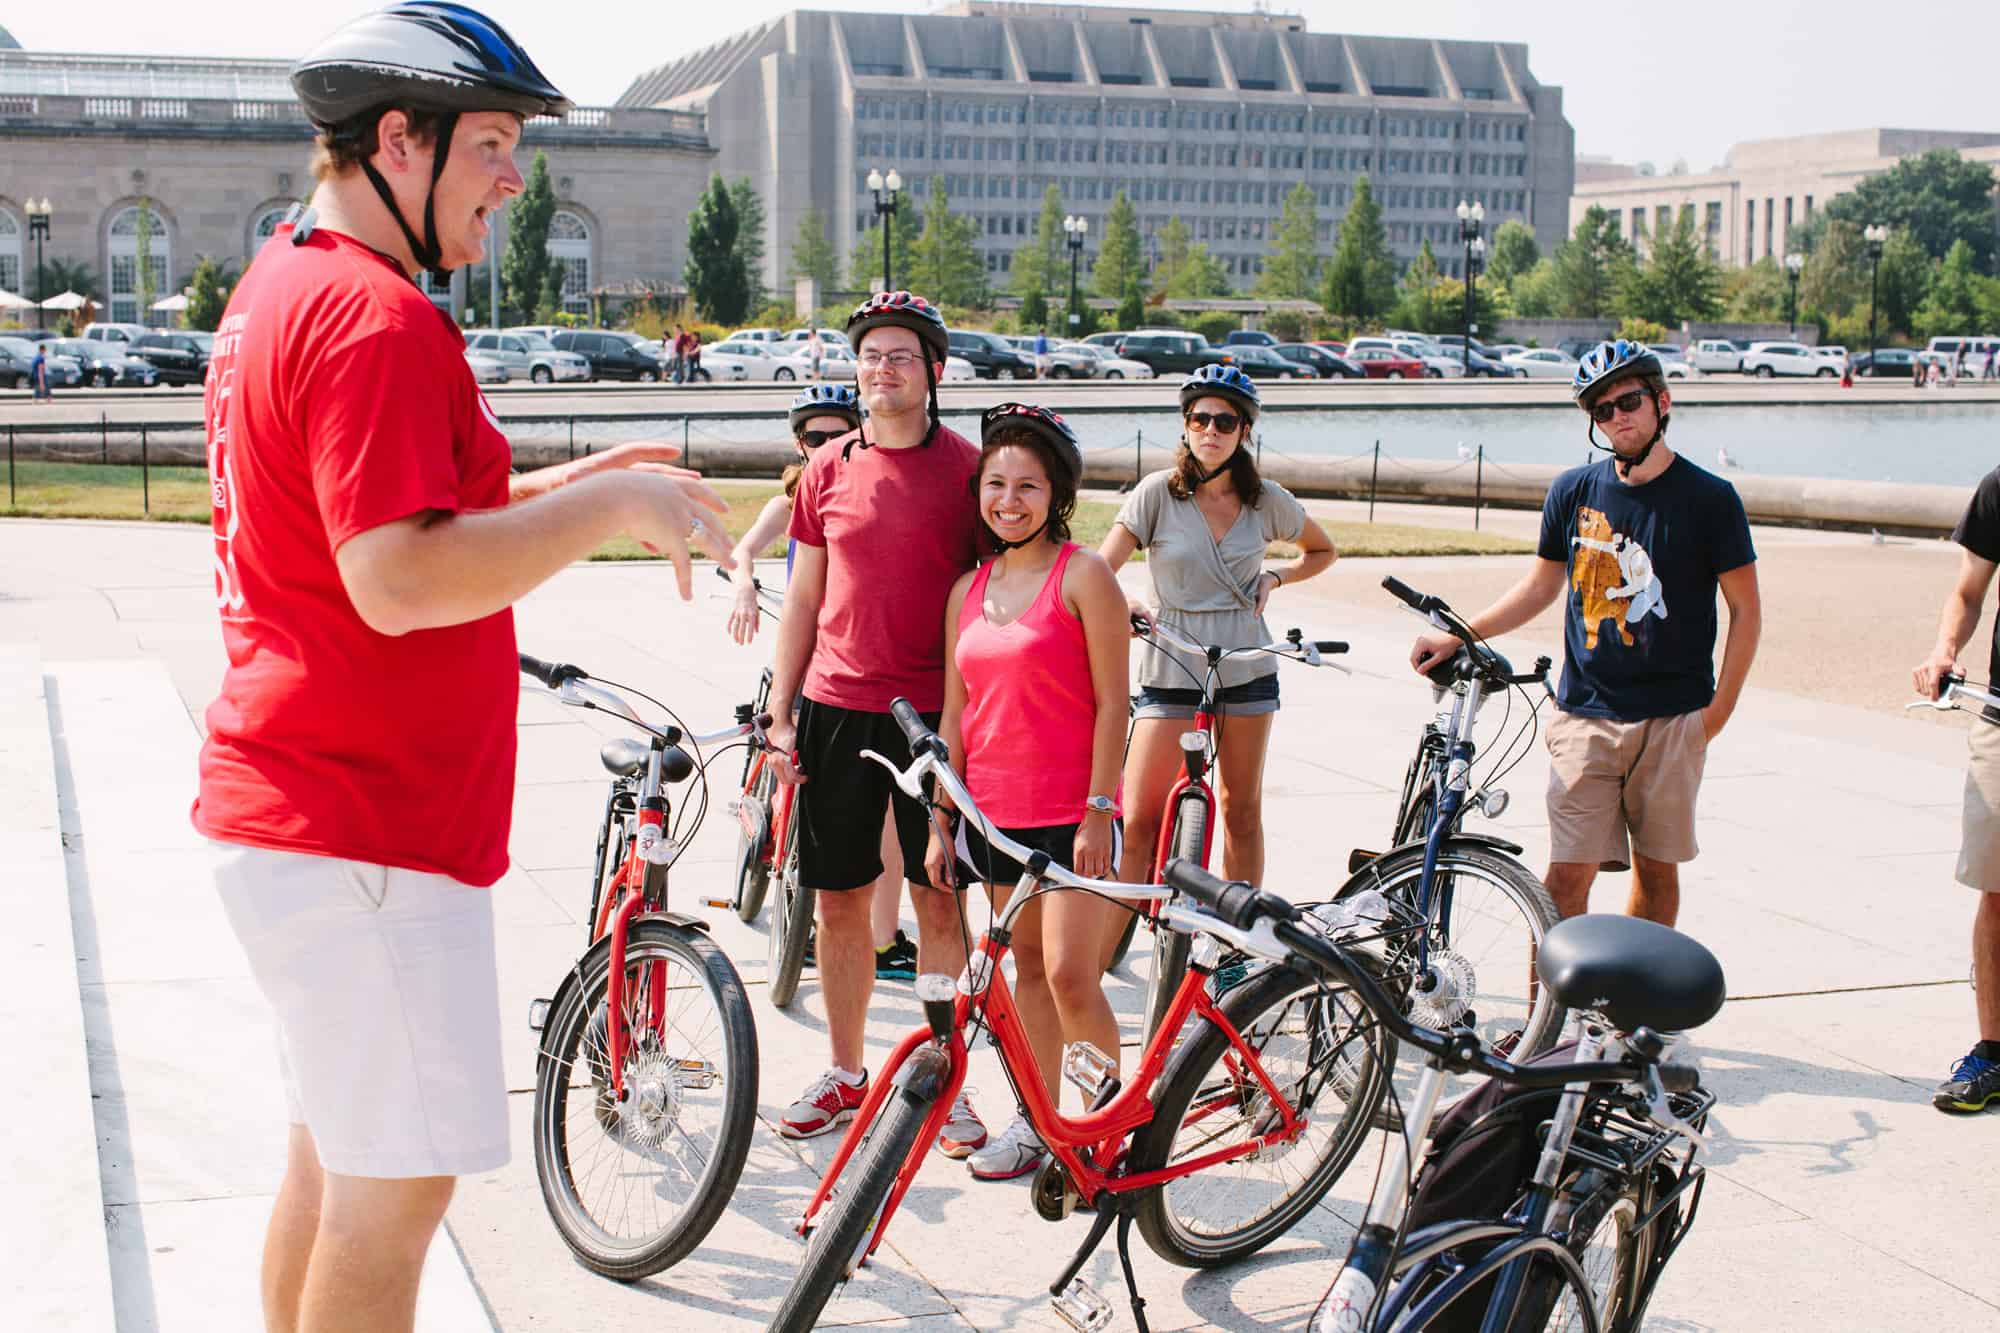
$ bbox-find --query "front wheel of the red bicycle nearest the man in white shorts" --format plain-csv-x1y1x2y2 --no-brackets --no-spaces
534,919,758,1281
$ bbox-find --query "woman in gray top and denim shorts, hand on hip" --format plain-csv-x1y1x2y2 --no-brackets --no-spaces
1098,366,1336,896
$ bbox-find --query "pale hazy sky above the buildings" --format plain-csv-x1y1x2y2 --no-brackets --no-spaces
0,0,2000,170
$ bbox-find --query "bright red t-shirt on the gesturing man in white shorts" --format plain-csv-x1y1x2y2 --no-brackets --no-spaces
194,226,518,885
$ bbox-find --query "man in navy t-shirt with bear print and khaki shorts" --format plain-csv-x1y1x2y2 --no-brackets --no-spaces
1410,338,1762,925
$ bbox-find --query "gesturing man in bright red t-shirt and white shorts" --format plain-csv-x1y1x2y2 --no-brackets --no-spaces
194,2,728,1329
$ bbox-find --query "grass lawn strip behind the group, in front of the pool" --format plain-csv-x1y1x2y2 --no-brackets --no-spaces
0,458,1534,560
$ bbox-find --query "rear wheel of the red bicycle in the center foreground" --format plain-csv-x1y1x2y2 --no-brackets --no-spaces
1132,967,1394,1269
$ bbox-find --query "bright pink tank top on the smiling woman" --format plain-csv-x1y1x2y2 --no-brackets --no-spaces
956,542,1098,829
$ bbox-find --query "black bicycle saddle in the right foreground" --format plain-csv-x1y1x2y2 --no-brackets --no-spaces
1536,915,1726,1033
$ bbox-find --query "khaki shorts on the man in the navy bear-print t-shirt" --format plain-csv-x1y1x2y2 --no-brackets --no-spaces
1548,711,1708,871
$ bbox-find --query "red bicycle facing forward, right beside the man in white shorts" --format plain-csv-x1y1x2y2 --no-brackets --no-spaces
520,654,768,1281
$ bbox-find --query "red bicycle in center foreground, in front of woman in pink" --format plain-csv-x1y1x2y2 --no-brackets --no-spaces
770,699,1394,1333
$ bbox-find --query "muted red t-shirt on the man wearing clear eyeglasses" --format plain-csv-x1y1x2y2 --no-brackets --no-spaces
792,426,980,713
